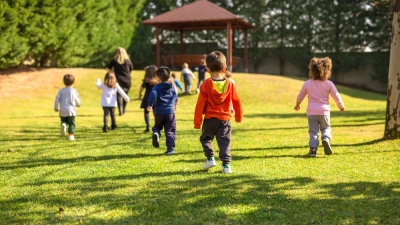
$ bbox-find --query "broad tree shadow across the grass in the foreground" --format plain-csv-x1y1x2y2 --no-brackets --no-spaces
0,171,400,224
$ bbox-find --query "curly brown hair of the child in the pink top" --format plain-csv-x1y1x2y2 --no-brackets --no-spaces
308,57,332,80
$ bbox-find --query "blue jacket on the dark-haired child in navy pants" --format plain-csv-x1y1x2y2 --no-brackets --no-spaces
149,82,178,115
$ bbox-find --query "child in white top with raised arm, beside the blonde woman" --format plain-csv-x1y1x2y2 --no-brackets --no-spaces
96,72,129,132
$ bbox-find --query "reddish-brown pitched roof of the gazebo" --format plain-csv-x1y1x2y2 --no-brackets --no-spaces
142,0,255,31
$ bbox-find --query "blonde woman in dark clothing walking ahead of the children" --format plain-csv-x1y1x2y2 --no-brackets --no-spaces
106,47,133,116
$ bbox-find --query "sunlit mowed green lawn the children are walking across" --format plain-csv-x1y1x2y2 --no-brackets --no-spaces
0,70,400,224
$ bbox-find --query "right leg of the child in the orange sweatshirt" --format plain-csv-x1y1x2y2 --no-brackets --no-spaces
215,120,232,165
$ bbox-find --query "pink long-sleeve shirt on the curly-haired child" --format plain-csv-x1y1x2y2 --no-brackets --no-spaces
297,79,344,115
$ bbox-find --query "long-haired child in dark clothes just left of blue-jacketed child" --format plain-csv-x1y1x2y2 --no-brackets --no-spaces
139,65,158,132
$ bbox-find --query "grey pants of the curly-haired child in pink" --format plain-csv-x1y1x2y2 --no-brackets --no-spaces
308,115,332,148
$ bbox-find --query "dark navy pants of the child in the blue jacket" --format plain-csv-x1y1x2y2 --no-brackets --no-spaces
153,114,176,150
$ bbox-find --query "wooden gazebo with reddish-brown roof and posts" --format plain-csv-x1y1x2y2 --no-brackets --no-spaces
142,0,255,72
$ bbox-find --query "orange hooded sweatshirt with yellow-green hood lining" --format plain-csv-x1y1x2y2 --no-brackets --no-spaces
194,78,243,129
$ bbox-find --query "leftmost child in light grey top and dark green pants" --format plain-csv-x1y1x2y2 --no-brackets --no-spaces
54,74,81,141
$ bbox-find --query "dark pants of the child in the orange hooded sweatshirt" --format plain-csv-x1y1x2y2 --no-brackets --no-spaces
200,118,232,164
